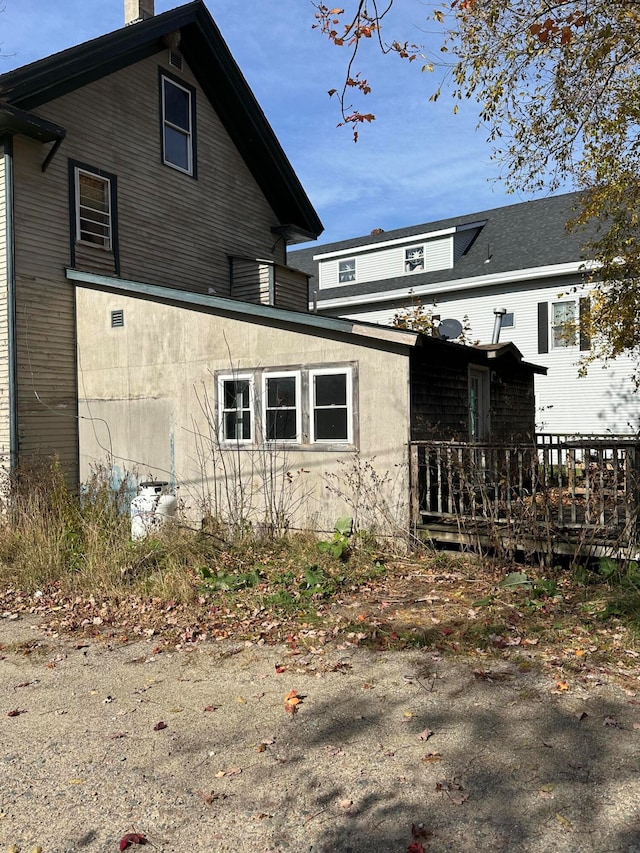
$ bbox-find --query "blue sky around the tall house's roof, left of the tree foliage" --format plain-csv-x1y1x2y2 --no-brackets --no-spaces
0,0,556,243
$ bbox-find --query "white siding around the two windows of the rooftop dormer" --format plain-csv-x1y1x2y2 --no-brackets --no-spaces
318,235,453,289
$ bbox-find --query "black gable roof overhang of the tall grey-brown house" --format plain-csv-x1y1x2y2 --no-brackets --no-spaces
0,0,323,242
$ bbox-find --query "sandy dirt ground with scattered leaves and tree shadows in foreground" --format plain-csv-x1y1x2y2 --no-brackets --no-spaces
0,614,640,853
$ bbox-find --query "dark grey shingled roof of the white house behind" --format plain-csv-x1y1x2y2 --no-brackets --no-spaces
289,193,589,301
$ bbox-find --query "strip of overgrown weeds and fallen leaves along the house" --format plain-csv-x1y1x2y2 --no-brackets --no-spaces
0,466,640,677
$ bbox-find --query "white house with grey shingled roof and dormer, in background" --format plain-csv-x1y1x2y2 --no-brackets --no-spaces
288,193,640,434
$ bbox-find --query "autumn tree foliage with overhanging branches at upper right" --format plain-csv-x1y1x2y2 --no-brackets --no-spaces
316,0,640,372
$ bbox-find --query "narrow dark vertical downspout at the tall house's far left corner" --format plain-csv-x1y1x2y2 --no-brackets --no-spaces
0,136,18,470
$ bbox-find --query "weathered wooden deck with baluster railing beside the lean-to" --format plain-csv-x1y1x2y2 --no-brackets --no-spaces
410,433,640,558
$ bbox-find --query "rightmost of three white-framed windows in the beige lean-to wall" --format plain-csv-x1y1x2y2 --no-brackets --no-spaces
309,368,353,444
